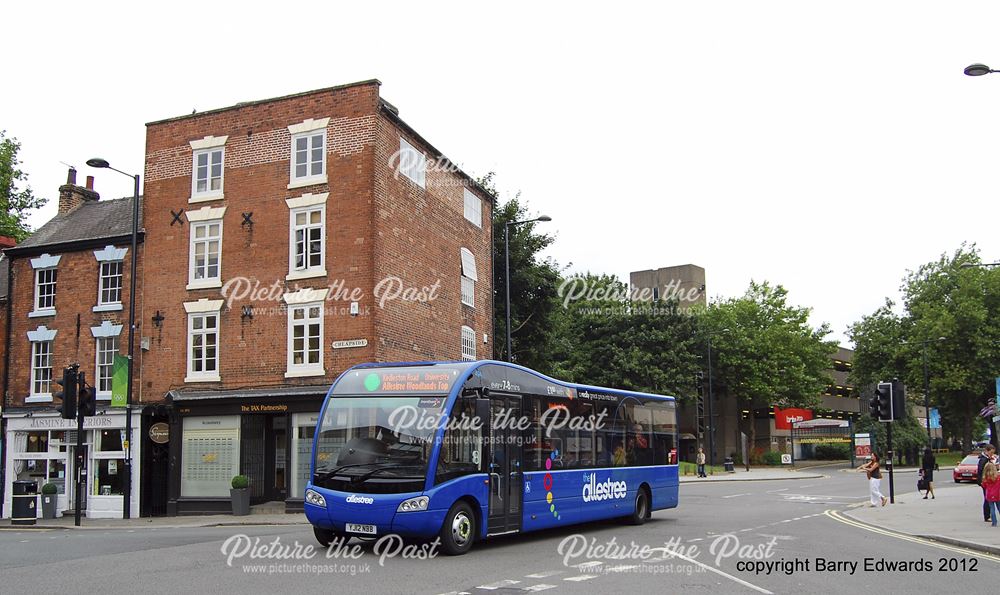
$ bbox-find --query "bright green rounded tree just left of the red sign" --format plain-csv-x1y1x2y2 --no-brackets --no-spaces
700,281,837,448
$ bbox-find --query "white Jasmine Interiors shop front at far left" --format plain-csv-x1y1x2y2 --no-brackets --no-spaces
4,409,139,518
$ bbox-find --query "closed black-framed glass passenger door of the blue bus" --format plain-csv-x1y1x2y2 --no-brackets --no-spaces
487,394,524,535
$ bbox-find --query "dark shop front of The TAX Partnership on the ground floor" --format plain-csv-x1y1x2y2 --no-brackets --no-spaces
167,386,328,515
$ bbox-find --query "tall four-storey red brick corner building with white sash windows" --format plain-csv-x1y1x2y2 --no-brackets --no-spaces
140,81,493,514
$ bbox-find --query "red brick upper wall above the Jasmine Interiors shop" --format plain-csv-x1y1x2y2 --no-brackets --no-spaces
8,244,142,406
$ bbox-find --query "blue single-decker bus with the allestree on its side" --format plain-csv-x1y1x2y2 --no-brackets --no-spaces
305,360,678,555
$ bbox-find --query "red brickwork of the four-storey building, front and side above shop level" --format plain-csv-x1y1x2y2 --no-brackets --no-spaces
141,83,492,398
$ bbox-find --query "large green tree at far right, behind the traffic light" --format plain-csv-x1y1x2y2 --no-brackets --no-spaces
848,245,1000,450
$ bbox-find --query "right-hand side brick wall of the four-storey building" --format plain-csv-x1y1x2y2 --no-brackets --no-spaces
375,115,493,361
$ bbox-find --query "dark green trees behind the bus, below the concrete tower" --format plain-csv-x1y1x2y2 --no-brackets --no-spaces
553,274,700,400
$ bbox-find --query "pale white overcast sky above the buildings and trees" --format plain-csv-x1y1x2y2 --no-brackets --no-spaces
7,1,1000,342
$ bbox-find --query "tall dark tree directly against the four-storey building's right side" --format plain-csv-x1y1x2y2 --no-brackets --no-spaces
478,172,559,373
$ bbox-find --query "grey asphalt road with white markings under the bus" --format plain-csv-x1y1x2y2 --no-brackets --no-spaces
0,469,1000,595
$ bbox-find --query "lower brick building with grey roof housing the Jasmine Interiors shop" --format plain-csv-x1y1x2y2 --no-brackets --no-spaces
3,168,141,517
